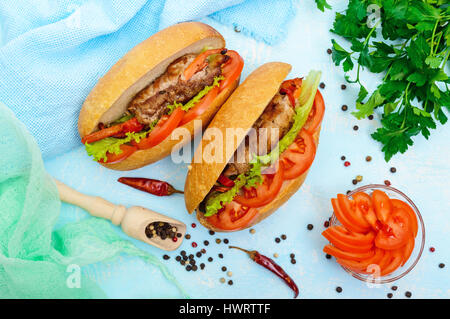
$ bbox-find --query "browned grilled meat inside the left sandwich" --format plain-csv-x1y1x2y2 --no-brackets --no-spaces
128,54,228,125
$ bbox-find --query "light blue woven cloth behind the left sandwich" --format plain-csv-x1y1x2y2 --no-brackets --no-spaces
0,0,295,158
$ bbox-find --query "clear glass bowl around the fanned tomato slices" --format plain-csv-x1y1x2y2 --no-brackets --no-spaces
330,184,425,284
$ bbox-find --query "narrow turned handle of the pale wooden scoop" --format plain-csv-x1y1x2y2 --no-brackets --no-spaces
53,178,127,225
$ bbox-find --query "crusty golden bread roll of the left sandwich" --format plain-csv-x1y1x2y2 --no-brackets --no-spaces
78,22,239,170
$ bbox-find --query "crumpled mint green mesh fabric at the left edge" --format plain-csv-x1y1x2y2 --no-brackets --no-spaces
0,104,186,298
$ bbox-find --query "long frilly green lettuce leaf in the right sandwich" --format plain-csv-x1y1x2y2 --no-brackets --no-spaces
205,71,321,217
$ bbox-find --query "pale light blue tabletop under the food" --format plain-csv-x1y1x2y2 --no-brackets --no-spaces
45,1,450,298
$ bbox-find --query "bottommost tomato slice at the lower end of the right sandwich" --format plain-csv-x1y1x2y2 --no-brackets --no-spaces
206,201,258,230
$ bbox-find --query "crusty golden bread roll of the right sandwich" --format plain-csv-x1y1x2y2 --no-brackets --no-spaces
184,62,320,232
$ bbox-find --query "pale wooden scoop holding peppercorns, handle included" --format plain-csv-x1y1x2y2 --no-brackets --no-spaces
54,179,186,250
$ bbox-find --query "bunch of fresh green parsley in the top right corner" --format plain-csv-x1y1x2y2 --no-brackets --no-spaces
331,0,450,161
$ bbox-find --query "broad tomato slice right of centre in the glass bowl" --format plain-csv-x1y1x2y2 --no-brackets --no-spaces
375,208,412,250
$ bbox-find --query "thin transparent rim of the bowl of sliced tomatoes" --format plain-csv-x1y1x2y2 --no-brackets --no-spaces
330,184,425,284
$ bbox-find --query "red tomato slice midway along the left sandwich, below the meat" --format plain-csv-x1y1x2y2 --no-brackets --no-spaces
137,107,186,150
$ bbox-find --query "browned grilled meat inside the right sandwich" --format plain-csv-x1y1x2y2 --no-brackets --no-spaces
223,93,295,176
